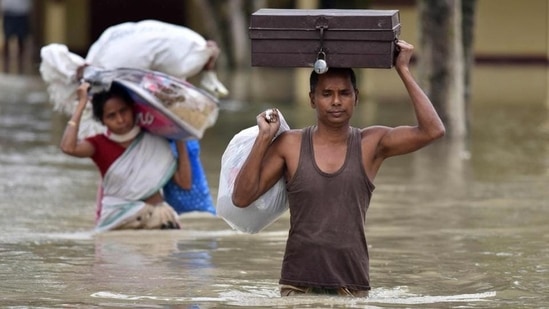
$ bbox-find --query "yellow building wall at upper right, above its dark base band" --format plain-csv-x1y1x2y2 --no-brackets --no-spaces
372,0,549,63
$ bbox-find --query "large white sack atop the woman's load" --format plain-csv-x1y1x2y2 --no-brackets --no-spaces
86,20,213,79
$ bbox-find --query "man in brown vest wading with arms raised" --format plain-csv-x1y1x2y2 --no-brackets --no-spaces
232,40,445,297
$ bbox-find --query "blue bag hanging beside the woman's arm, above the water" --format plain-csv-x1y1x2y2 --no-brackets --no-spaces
163,140,216,215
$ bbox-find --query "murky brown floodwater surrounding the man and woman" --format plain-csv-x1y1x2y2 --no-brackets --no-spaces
0,69,549,309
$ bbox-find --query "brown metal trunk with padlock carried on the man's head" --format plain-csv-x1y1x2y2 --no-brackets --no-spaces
249,9,400,69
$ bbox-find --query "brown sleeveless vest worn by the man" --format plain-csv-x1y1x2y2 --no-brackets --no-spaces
280,127,374,290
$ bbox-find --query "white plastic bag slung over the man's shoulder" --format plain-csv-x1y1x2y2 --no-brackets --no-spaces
217,112,290,234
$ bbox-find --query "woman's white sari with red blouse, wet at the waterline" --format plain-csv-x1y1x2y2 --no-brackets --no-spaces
88,131,179,232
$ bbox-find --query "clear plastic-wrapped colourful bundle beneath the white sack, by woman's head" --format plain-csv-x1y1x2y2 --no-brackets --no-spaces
84,66,219,140
